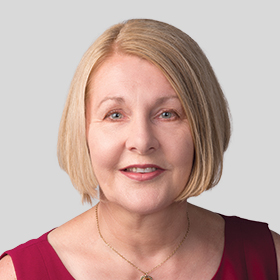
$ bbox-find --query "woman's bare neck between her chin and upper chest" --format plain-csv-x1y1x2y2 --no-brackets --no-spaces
95,202,188,258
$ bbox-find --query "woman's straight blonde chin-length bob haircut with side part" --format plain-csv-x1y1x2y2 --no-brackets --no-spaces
57,19,231,203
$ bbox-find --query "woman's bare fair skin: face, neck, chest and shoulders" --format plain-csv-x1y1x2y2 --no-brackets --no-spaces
0,54,280,280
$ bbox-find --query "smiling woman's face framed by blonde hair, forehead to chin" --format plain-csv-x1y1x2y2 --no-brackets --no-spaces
86,54,194,213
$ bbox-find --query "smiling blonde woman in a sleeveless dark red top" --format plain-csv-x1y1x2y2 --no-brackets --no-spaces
0,20,280,280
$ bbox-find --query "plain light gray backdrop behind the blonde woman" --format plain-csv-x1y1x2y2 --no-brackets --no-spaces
0,0,280,252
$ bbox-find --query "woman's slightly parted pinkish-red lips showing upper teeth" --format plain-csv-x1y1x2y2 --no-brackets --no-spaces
120,165,165,181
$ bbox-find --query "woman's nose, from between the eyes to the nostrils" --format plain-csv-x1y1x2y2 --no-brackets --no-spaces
126,117,159,155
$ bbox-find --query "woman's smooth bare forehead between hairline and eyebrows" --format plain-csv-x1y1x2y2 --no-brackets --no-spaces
87,55,177,99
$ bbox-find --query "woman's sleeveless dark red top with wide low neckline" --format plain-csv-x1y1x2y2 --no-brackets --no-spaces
0,216,278,280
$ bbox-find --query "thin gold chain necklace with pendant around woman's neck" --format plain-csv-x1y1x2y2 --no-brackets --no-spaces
95,203,191,280
